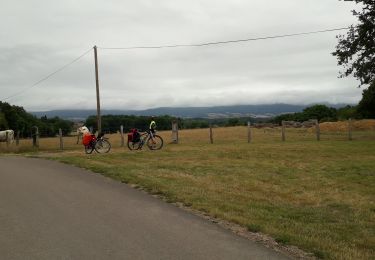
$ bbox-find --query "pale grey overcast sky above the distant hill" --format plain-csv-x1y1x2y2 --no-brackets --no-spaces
0,0,362,111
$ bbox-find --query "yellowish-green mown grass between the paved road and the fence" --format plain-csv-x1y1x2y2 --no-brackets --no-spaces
1,127,375,259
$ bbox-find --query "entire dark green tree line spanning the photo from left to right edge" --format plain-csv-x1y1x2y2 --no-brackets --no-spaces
0,99,375,138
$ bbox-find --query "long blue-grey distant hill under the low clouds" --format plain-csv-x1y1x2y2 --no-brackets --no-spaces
30,104,352,121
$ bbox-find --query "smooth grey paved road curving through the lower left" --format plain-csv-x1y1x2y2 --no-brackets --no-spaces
0,157,287,260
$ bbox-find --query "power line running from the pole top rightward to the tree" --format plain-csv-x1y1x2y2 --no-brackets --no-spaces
98,27,349,50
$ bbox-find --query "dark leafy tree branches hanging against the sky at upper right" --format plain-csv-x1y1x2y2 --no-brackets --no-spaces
332,0,375,86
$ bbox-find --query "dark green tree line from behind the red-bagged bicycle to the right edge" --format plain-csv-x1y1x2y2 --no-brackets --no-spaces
85,102,375,133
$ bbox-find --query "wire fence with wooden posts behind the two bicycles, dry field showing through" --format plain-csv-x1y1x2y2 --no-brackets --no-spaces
0,120,375,153
